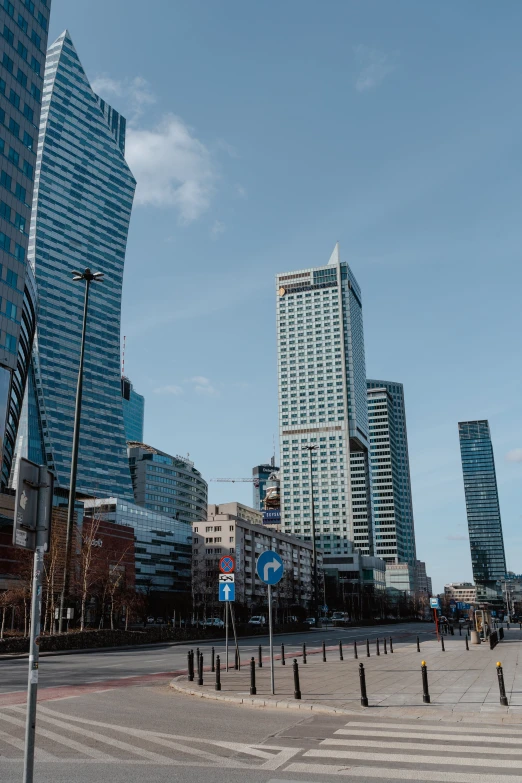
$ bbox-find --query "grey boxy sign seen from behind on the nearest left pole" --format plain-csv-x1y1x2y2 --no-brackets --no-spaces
13,458,54,552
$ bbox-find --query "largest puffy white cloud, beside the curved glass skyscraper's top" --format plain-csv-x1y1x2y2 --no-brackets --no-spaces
126,114,216,223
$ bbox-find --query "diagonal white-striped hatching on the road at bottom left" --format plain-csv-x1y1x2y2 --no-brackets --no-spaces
0,704,300,770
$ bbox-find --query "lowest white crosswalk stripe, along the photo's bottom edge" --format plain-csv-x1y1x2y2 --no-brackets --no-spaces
282,763,522,783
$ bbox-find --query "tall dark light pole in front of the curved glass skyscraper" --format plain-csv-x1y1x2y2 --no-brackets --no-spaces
58,267,103,633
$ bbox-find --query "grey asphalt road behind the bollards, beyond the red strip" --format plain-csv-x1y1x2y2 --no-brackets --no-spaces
0,623,433,696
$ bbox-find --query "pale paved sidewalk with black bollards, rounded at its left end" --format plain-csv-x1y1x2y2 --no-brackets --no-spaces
171,628,522,724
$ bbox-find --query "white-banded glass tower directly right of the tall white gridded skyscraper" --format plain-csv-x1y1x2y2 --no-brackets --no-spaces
367,380,416,566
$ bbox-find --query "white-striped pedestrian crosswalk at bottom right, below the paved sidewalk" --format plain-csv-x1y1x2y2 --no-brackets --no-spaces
284,718,522,783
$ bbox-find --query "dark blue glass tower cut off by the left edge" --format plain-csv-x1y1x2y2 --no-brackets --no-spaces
0,0,51,488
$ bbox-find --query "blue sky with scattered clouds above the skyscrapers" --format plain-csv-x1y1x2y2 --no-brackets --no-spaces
50,0,522,591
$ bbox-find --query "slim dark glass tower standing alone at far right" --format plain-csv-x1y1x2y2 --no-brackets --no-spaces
459,420,506,603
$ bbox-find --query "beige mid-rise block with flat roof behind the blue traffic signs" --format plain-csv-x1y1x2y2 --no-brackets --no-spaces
192,503,322,609
